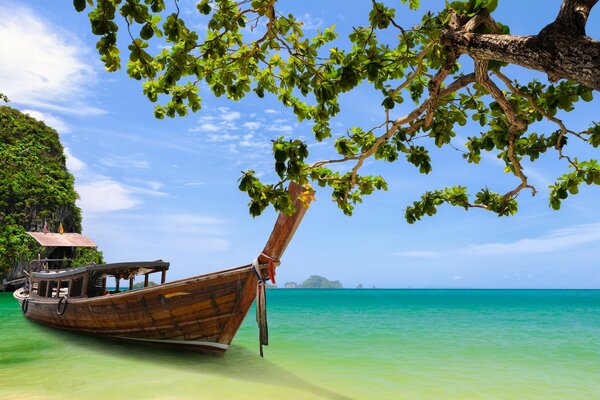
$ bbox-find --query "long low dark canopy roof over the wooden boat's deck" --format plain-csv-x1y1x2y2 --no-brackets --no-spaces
31,260,169,279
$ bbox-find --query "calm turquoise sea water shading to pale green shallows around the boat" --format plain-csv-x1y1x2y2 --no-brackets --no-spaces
0,290,600,400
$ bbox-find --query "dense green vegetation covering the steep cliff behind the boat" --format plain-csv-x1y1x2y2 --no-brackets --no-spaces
0,106,102,271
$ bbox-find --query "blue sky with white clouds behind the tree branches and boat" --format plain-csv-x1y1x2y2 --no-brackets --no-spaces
0,0,600,288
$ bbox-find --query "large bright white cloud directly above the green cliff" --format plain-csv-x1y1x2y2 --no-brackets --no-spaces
0,4,104,115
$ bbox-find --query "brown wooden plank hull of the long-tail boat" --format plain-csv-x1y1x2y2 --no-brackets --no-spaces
14,266,257,354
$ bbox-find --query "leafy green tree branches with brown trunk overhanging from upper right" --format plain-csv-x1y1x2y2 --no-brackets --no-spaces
74,0,600,219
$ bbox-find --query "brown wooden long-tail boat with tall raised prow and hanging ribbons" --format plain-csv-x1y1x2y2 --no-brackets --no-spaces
14,183,310,355
